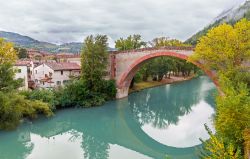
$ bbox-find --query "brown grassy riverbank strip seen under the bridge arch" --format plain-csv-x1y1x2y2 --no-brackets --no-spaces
129,75,196,94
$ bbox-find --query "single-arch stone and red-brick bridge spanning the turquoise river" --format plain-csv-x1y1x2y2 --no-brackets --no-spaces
110,47,218,98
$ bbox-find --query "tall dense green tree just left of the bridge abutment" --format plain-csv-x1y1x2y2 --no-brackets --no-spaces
81,35,108,90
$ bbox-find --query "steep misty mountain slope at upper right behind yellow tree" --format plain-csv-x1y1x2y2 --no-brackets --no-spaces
186,0,250,45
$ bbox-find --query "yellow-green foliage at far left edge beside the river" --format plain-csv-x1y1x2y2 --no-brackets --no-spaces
0,39,53,129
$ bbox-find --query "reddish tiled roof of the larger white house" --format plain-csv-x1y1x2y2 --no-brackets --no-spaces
44,62,81,71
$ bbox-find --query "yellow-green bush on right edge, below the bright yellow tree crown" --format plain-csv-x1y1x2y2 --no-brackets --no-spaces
215,77,250,148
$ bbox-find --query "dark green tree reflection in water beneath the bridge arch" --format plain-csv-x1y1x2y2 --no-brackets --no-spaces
129,77,214,128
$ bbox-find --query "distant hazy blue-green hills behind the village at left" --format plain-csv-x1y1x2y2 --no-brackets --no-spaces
0,31,83,53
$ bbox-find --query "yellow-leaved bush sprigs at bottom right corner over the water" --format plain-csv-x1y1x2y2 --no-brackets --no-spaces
200,125,242,159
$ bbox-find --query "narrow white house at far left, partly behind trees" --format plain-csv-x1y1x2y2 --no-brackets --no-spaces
14,60,34,90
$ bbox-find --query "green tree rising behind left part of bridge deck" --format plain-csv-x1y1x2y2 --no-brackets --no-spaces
115,34,146,51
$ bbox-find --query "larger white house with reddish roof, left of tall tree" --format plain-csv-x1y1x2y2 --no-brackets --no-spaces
34,62,81,88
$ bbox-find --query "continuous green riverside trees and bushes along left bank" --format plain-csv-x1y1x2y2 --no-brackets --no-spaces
0,35,116,130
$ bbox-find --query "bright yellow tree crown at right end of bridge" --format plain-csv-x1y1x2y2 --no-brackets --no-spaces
191,19,250,72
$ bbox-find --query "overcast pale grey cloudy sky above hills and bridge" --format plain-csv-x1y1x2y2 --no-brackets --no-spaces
0,0,244,43
